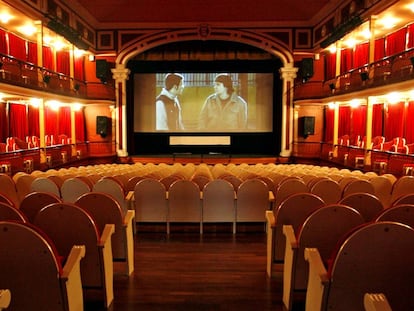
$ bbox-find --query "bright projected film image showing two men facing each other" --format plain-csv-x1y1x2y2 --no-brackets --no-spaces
133,72,273,133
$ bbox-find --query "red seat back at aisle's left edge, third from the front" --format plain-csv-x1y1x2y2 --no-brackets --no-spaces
75,192,127,260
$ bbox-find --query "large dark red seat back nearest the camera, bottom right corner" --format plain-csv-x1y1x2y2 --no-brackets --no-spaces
325,222,414,311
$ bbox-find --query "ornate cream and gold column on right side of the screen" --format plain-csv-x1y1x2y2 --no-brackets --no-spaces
280,63,298,157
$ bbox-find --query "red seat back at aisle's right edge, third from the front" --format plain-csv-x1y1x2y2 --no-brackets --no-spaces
273,192,325,262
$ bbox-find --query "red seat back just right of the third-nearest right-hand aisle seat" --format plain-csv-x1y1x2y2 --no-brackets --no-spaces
340,192,384,222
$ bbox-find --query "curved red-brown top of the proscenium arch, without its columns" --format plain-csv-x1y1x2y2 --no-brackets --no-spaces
116,26,293,67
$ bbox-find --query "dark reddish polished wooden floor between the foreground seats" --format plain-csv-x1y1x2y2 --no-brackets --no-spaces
85,232,298,311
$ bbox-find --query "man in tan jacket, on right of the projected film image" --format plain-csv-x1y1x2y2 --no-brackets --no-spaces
199,74,247,131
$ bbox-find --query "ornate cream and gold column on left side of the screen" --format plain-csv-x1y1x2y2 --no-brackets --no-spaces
111,64,130,157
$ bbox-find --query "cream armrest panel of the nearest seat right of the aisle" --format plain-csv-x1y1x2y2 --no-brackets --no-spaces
305,248,329,311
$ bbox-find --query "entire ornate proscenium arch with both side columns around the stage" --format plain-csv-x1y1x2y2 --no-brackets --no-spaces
112,24,298,157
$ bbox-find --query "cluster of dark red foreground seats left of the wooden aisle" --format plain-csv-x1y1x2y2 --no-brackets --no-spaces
0,192,134,310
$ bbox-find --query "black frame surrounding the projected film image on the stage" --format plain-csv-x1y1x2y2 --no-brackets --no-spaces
126,59,283,155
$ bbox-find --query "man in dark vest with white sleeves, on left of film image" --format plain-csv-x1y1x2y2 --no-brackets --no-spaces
155,73,184,131
